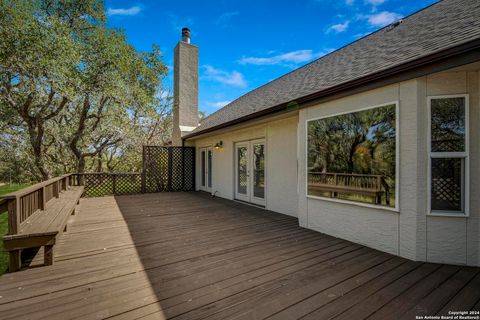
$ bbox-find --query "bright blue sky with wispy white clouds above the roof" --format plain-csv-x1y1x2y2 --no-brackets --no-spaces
106,0,436,114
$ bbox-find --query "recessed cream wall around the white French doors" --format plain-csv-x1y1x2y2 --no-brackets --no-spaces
190,114,298,216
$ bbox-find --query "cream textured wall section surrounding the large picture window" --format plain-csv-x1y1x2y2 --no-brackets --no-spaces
299,84,404,254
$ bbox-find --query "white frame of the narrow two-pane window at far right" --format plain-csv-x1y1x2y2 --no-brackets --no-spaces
427,94,470,218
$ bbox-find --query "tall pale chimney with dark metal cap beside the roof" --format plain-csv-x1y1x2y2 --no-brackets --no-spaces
172,28,198,146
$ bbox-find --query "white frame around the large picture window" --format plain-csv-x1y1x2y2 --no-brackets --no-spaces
305,100,400,213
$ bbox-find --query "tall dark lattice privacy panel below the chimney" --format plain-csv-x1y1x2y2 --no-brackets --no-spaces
143,146,195,192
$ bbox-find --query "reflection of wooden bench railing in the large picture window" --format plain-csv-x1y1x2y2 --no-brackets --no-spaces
308,172,390,205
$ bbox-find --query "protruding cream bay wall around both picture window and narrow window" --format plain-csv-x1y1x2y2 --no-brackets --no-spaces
298,70,480,265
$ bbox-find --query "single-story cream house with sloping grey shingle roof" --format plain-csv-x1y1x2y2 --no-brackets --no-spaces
175,0,480,266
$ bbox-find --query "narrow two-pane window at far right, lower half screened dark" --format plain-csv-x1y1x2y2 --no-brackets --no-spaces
428,95,468,215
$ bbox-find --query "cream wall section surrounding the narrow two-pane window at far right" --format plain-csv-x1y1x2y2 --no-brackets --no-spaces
422,71,480,265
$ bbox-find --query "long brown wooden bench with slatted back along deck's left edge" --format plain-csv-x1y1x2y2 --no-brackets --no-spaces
3,175,83,272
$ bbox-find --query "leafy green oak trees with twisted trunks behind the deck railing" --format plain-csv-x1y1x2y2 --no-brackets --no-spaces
0,0,171,180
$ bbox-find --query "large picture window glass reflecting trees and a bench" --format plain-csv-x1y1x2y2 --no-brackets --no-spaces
307,103,398,208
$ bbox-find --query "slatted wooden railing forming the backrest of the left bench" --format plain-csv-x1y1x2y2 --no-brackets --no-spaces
0,174,71,235
